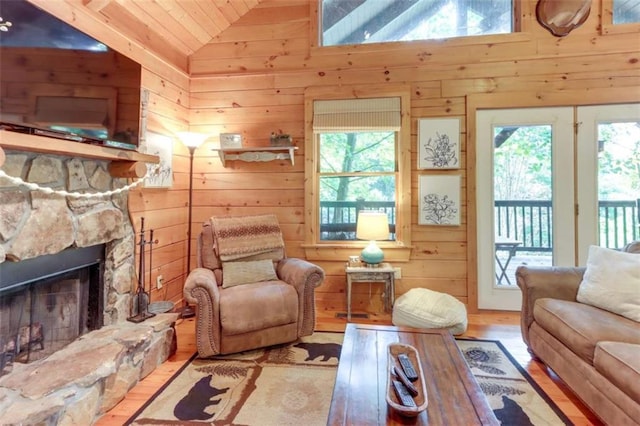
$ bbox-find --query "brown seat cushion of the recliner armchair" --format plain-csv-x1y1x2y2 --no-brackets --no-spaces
220,280,298,336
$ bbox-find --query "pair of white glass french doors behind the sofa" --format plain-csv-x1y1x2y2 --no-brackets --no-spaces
476,104,640,310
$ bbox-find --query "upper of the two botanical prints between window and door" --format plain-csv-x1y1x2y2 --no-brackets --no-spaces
418,118,460,170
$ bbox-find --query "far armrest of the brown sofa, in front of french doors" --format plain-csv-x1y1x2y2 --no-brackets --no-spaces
516,266,585,345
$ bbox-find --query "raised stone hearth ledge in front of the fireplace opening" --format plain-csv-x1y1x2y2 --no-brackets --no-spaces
0,314,178,425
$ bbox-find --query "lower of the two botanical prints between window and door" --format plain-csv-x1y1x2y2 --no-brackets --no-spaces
418,175,461,226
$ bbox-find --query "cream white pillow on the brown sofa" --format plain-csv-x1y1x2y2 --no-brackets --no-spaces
577,246,640,322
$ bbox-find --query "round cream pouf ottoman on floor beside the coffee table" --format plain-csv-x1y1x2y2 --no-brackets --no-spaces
392,288,467,335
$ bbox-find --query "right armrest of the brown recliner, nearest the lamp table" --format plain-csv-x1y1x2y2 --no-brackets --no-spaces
276,258,324,337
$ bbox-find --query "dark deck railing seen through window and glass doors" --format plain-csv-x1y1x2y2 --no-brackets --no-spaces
320,199,640,252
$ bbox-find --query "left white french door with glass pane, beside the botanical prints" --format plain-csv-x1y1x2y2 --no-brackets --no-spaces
477,107,575,310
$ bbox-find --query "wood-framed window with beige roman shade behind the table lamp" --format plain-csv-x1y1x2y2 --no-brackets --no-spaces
305,86,411,260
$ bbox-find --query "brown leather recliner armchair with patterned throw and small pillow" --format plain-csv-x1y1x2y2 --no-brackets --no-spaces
184,215,324,357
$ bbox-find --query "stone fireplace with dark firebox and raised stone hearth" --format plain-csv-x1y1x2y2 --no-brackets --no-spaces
0,148,177,424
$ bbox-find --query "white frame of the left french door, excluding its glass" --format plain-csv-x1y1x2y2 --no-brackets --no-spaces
476,107,575,311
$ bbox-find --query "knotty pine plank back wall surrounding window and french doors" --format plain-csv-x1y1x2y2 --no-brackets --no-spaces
180,0,640,310
